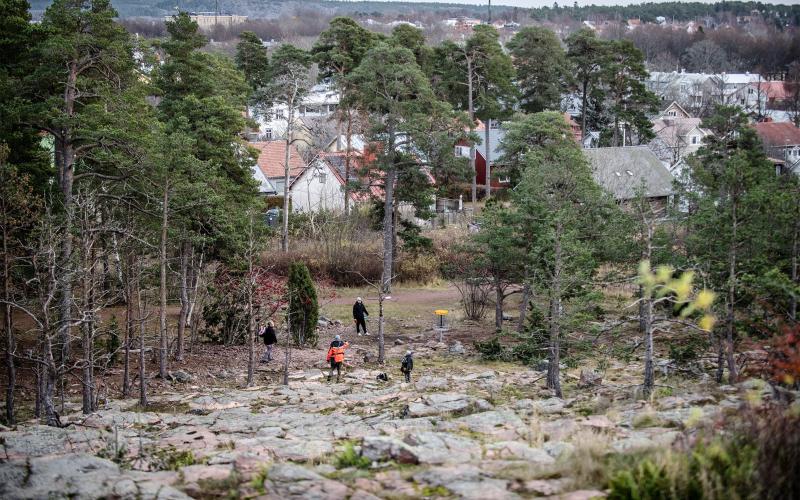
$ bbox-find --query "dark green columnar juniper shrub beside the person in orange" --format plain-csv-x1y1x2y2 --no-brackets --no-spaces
287,262,319,346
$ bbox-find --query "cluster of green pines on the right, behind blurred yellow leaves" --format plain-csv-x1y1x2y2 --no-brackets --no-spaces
462,106,800,397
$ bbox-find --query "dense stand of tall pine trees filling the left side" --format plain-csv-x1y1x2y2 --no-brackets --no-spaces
0,0,262,425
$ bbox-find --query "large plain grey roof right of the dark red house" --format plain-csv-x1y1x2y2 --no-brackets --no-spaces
583,146,674,201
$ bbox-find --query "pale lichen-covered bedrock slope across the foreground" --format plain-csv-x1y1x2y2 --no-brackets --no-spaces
0,338,767,499
